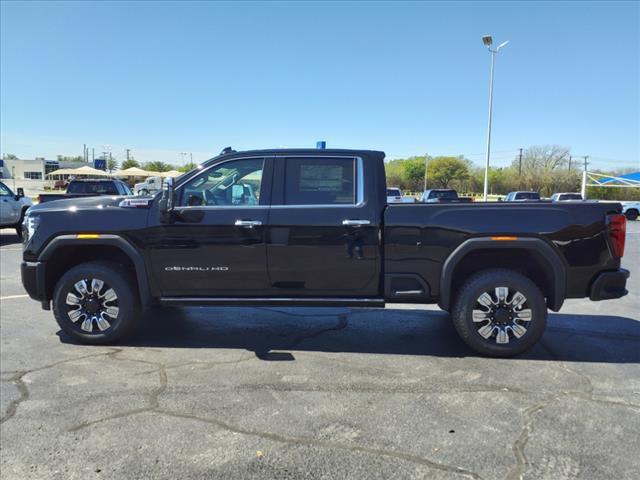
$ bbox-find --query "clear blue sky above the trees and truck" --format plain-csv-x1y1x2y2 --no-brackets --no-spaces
0,1,640,168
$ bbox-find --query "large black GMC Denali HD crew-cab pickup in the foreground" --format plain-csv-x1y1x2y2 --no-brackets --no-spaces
22,150,629,356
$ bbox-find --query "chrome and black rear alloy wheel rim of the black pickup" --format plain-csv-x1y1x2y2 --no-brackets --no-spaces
473,287,533,344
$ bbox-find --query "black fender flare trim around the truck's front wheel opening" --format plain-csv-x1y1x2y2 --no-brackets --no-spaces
38,234,150,306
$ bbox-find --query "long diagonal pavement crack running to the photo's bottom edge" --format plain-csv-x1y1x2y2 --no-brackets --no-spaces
156,409,482,480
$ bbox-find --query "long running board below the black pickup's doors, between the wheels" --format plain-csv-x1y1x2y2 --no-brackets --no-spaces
160,297,384,308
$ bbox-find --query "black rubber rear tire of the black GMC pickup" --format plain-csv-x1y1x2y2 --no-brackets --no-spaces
451,269,547,357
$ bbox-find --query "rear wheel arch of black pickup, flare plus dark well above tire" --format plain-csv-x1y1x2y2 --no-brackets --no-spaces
438,237,566,311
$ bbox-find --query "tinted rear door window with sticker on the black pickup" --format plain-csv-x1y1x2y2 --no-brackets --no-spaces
284,157,356,205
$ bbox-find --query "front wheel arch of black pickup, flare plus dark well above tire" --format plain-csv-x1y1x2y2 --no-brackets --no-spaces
38,234,150,305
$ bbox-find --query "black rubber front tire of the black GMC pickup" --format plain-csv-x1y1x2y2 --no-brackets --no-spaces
53,262,140,345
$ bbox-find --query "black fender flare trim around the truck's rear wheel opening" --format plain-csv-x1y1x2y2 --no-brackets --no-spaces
438,237,567,312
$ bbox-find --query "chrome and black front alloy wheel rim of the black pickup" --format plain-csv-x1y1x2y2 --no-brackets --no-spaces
65,278,119,333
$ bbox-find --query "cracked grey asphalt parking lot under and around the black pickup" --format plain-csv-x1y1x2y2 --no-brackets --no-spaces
0,222,640,480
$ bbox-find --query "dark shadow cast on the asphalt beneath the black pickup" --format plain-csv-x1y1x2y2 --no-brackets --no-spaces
85,307,640,363
